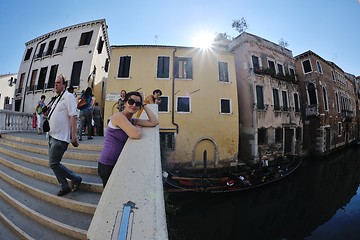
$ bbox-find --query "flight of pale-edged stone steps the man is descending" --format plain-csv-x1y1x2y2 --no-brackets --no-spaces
0,133,103,240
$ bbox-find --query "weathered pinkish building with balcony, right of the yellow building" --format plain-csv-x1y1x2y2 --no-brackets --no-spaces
228,32,302,163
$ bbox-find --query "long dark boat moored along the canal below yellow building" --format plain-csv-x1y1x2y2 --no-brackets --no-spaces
165,156,302,193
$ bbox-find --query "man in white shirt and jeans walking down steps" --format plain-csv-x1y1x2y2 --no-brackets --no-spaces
49,75,82,196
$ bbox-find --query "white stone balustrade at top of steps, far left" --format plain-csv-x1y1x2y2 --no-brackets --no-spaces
0,110,35,133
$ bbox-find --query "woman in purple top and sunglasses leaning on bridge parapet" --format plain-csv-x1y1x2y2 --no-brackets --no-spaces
98,92,159,187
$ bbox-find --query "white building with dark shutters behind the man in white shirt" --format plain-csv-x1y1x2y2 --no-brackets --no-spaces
15,19,110,113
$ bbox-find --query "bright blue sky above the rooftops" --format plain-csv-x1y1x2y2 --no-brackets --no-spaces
0,0,360,76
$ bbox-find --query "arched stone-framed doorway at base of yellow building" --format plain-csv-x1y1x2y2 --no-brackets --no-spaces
192,137,219,166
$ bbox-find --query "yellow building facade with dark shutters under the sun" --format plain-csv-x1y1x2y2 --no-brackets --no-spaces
104,46,239,167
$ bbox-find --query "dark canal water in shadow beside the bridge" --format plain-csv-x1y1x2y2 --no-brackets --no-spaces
166,148,360,240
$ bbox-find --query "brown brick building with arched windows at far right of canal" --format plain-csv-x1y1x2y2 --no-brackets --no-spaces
295,51,357,156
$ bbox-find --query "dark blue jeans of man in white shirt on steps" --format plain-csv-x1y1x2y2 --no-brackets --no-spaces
49,136,79,189
